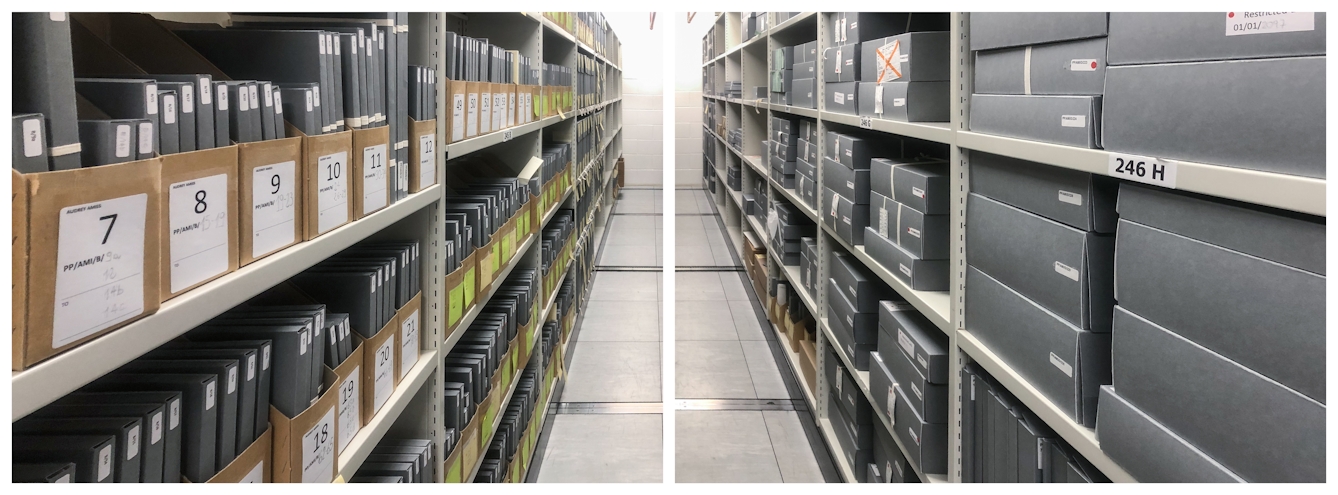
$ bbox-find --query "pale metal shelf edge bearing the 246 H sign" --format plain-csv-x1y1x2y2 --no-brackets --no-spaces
957,131,1326,217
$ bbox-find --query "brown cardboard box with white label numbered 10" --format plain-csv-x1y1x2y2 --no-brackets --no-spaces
285,123,355,241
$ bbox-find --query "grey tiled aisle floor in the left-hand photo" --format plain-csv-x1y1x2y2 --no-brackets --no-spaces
530,189,664,483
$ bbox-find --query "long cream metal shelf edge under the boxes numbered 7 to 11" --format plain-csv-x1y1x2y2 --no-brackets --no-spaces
11,185,443,419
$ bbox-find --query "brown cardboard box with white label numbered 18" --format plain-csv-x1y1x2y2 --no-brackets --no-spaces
269,369,339,483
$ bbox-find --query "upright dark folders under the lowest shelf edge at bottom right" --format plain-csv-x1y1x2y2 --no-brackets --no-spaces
962,363,1109,483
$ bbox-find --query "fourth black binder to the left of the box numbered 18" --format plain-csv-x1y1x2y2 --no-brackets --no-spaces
87,373,218,483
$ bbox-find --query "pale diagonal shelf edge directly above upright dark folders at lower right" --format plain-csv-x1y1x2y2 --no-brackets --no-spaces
957,330,1136,483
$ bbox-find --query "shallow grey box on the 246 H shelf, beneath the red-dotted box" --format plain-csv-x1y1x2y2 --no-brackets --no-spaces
970,94,1102,149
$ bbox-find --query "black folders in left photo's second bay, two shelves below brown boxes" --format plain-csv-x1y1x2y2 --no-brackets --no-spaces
443,268,539,441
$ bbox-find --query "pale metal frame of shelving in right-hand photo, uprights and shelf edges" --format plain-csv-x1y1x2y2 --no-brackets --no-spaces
701,12,1326,482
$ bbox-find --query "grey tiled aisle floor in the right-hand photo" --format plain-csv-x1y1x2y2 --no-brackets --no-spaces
674,190,838,483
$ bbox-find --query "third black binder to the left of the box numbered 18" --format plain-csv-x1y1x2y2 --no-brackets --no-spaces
122,359,240,470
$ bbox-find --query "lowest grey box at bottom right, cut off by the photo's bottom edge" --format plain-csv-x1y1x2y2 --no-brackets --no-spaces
1096,385,1246,483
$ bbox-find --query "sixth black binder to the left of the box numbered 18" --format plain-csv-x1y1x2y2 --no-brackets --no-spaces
35,403,167,483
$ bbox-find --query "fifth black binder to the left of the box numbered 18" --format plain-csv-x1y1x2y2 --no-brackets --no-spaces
60,391,185,483
